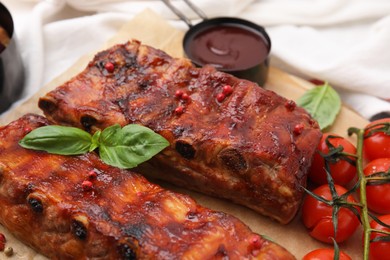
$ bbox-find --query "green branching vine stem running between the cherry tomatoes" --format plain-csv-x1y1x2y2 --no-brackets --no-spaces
304,119,390,260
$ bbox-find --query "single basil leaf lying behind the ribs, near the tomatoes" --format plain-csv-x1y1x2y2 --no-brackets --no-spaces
297,83,341,129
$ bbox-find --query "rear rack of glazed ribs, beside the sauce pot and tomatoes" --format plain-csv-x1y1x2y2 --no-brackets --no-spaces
39,40,321,223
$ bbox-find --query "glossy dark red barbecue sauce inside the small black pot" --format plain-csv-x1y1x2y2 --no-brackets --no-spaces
187,24,270,70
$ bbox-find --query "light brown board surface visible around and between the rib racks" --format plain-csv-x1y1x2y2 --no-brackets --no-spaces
0,10,367,260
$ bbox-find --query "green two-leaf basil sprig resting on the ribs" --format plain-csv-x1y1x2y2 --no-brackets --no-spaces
19,124,169,169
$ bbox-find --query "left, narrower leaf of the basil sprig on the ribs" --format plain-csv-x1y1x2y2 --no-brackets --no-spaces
19,125,92,155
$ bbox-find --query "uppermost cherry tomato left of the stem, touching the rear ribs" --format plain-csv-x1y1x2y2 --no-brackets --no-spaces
308,133,356,186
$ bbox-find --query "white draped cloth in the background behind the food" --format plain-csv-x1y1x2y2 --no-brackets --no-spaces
2,0,390,119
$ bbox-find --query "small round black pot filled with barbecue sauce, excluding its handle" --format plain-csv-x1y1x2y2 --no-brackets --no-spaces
183,17,271,86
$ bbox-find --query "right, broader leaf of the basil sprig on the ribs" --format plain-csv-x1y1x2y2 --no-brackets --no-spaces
99,124,169,168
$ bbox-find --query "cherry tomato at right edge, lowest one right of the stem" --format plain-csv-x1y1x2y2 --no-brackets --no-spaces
370,215,390,260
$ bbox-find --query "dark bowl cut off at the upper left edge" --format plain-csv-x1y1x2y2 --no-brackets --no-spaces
0,3,24,113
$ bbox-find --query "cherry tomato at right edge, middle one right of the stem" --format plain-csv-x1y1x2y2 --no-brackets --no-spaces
364,158,390,214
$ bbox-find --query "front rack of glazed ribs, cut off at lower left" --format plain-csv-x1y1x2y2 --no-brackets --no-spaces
0,114,294,259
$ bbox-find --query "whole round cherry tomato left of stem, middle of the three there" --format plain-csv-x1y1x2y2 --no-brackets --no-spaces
302,184,360,244
